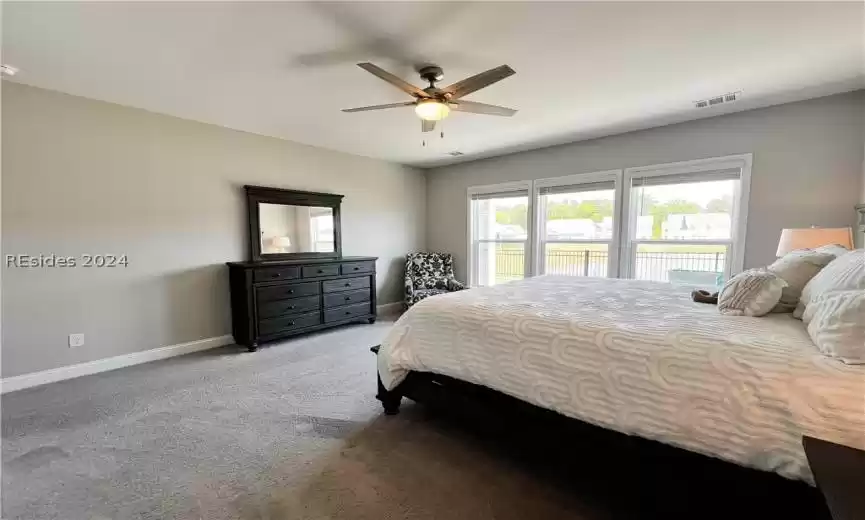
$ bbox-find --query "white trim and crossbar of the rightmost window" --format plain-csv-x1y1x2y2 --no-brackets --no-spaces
620,153,753,279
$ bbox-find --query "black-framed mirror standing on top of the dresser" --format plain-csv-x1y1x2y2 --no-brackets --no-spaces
244,186,342,261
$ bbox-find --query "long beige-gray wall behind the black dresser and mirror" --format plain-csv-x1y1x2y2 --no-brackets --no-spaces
2,82,425,377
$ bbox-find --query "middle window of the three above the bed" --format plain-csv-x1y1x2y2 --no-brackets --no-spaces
535,171,621,277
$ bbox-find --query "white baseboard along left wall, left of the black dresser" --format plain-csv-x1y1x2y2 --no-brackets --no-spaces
0,335,234,394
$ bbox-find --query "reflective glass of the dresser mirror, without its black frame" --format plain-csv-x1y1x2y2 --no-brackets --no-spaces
258,202,334,255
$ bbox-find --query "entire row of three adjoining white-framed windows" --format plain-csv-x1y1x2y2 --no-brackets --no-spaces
469,154,751,288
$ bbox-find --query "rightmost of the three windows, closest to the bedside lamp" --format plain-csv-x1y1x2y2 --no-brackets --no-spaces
622,159,750,289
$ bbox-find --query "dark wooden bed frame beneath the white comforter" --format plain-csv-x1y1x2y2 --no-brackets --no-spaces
371,346,830,520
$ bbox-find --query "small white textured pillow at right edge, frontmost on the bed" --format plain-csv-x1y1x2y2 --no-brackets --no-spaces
802,288,865,365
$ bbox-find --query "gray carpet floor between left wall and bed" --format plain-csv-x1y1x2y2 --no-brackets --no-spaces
2,321,603,520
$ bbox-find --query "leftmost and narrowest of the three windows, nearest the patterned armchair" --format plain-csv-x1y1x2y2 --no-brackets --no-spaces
469,184,531,285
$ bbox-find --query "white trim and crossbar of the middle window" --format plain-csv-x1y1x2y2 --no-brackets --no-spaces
530,170,623,278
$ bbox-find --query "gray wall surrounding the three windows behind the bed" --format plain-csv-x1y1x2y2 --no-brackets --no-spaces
426,91,865,279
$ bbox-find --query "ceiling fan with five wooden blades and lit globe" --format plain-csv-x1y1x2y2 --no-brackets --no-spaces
343,63,517,132
